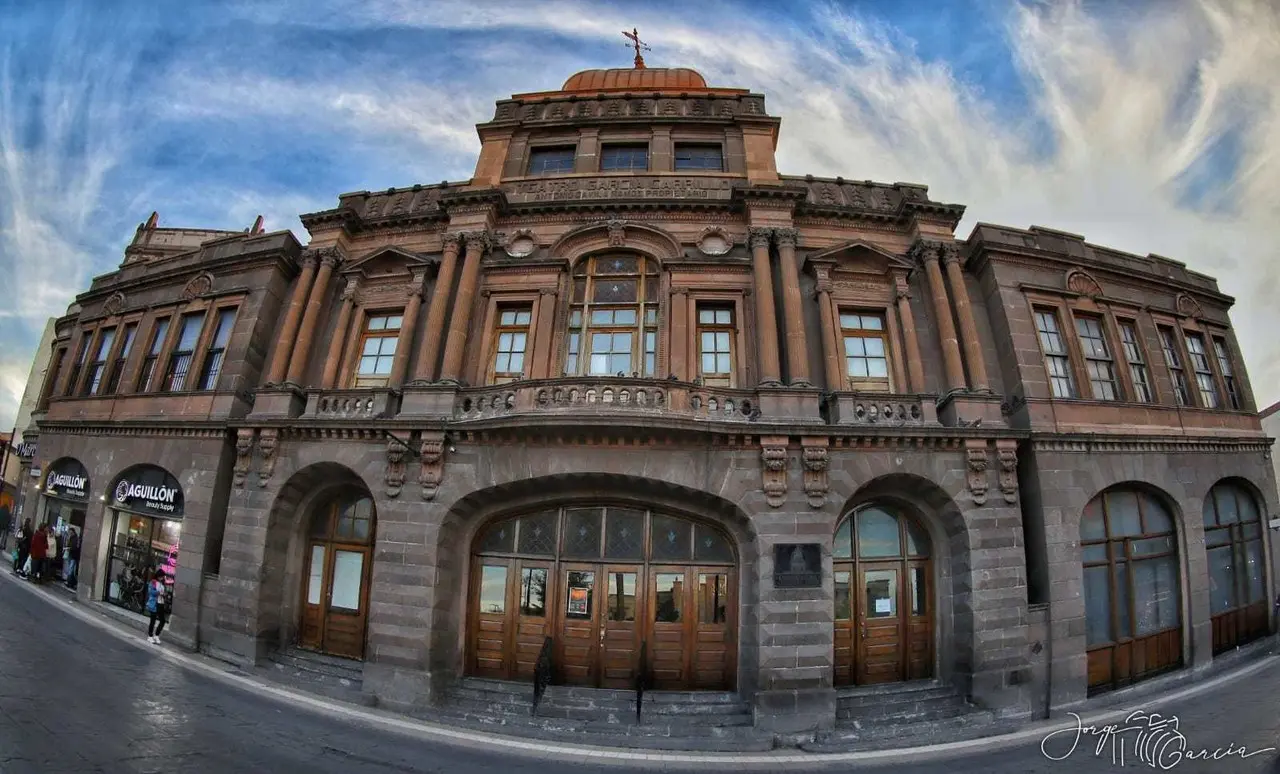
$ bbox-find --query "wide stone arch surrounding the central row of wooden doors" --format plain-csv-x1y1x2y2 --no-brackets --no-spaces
431,473,758,692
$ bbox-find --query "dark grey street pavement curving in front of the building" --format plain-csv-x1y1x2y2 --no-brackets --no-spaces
0,577,1280,774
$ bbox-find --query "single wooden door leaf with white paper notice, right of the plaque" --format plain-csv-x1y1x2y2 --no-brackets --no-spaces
858,564,904,684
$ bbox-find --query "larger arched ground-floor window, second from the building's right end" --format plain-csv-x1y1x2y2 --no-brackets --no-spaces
1080,486,1181,692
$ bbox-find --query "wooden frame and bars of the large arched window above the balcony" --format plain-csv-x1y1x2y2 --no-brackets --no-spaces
559,251,664,379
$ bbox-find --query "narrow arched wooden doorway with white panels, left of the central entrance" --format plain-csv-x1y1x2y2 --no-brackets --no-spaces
298,487,375,659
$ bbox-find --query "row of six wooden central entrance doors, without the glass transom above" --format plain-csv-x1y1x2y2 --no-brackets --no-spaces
467,557,737,690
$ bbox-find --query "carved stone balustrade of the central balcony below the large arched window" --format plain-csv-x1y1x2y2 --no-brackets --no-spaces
454,377,760,422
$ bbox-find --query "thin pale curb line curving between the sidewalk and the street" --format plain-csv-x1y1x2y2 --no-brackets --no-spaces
0,572,1280,766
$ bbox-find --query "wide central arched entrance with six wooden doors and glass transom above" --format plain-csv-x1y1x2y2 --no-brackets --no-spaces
467,505,737,690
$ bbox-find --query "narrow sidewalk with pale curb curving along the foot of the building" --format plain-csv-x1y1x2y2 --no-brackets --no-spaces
0,573,1276,770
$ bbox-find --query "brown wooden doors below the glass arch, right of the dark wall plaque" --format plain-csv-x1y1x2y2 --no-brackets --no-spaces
833,559,933,686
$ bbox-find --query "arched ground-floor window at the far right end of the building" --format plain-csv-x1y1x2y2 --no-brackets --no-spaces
1203,484,1267,654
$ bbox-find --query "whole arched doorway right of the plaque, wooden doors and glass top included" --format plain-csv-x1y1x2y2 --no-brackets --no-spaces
832,504,933,686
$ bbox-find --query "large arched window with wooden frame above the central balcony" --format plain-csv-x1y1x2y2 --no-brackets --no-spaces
564,253,659,376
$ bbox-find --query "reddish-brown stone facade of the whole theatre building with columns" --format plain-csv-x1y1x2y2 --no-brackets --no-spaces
15,63,1280,732
